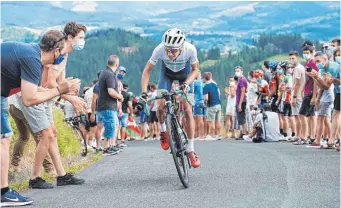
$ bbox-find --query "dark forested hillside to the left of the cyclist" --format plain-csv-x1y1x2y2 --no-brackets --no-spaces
67,29,159,93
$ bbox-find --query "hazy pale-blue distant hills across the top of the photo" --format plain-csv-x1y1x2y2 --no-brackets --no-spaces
1,1,340,51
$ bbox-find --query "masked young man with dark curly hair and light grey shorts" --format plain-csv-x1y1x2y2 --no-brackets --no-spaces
15,22,87,189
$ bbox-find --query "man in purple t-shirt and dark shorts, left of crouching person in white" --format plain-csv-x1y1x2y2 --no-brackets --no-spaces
235,66,248,139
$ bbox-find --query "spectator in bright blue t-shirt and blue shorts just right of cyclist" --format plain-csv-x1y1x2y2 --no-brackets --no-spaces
193,74,206,140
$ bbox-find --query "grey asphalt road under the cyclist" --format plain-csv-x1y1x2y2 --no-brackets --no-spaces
26,140,340,208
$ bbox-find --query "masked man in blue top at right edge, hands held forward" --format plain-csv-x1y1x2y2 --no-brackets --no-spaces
307,52,340,148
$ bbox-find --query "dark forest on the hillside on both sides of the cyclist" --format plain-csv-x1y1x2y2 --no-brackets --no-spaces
67,29,320,94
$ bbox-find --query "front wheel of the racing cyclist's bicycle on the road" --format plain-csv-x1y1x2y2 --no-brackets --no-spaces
166,115,189,188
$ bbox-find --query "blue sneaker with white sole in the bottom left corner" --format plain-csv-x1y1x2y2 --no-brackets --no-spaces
0,188,33,207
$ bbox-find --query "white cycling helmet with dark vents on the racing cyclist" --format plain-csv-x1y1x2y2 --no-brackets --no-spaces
162,28,186,48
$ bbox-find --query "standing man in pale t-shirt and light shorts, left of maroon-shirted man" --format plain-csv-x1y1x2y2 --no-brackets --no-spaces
289,51,308,144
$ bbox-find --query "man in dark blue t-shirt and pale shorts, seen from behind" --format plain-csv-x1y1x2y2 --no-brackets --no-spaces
203,72,221,140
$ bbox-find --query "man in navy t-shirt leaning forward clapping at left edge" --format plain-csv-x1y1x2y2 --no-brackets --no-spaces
0,30,80,206
